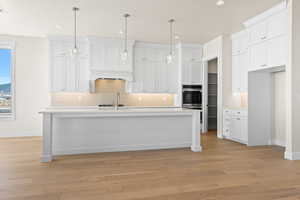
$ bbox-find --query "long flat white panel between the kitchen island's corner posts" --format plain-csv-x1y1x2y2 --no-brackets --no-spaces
53,113,193,155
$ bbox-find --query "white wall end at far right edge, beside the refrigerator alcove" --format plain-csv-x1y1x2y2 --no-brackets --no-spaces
285,0,300,160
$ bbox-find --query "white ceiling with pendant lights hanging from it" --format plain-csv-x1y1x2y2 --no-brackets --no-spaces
0,0,281,43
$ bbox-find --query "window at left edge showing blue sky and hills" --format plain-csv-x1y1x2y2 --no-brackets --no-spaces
0,42,14,118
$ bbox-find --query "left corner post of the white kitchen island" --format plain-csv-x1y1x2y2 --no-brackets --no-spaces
41,113,53,162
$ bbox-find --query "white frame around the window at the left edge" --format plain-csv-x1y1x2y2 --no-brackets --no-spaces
0,38,16,120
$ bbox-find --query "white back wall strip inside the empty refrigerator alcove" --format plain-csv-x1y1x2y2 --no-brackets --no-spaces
272,72,286,146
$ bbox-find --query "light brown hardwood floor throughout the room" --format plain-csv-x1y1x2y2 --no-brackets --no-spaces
0,133,300,200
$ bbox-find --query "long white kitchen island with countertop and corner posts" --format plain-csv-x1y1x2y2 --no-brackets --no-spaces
40,108,202,162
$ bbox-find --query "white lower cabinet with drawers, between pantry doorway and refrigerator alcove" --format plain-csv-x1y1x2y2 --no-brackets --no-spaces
223,109,248,144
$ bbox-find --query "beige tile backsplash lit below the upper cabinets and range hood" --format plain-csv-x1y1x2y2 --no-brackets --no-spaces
51,80,174,106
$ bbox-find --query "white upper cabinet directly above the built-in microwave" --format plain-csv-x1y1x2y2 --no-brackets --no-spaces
178,44,203,85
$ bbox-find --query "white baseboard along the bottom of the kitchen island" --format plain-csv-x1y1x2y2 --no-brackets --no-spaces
53,143,192,155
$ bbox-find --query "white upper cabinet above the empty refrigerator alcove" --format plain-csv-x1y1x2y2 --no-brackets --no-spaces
245,2,288,71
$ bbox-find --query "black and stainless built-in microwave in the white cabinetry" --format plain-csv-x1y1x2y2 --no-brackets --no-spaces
182,85,202,110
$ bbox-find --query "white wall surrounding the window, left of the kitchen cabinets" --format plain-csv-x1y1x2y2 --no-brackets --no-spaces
0,36,50,137
